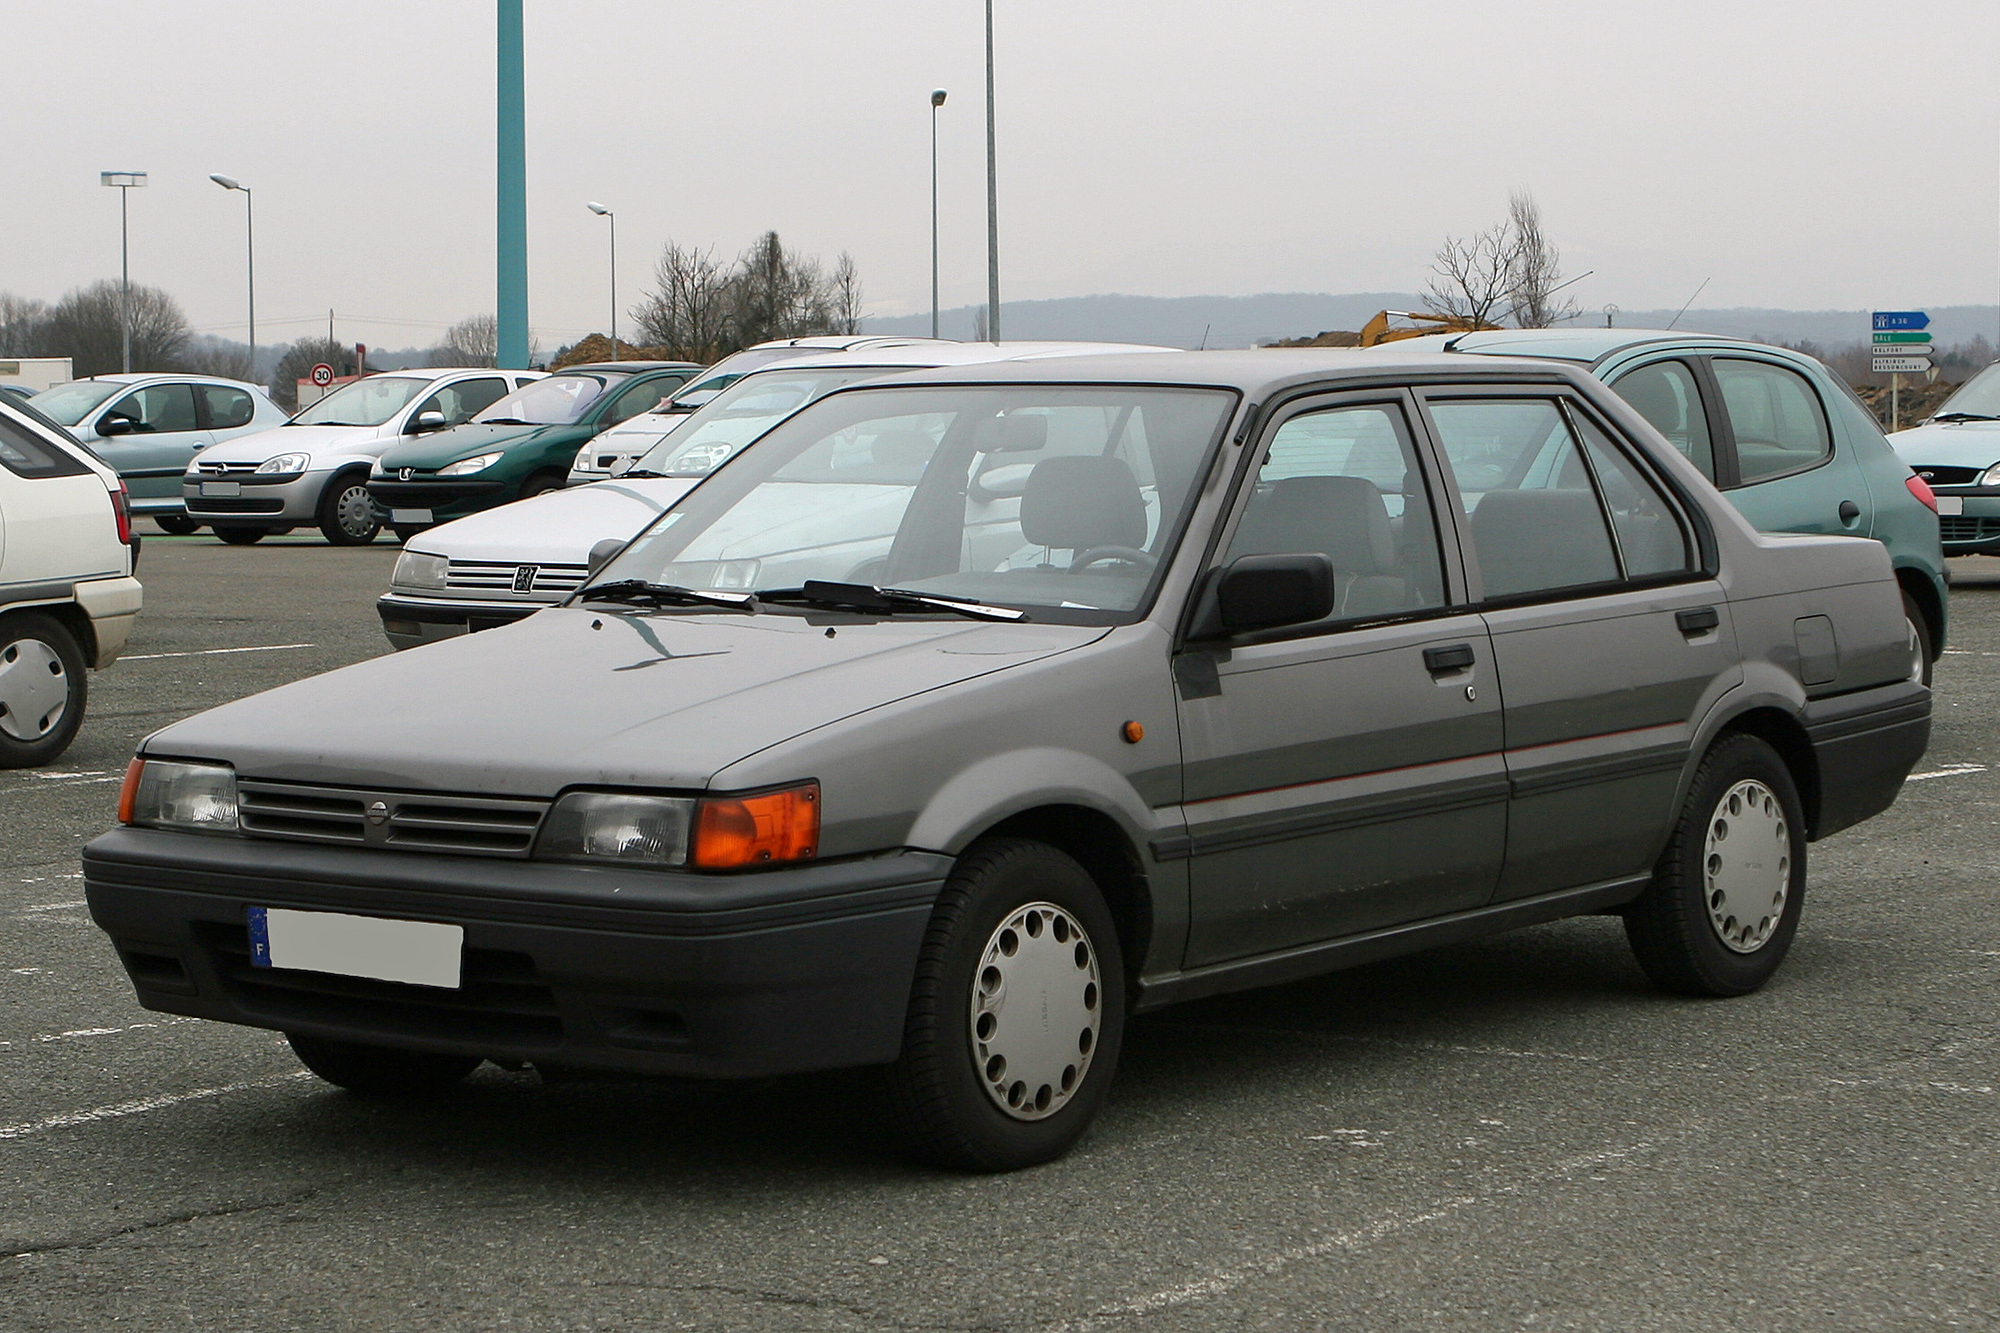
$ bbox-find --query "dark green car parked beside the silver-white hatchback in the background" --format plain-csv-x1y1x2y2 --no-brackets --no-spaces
368,360,700,536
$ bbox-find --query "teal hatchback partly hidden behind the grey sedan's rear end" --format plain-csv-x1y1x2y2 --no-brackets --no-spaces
1386,328,1944,685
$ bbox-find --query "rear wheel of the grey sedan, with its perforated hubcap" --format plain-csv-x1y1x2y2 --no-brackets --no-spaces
1624,733,1806,995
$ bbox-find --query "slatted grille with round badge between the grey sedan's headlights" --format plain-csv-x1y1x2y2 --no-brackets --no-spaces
236,779,548,859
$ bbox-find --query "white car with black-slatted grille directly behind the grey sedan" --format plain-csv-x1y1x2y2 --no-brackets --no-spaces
376,338,1174,648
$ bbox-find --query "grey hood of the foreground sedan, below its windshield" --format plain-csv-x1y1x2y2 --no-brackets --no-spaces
144,606,1108,797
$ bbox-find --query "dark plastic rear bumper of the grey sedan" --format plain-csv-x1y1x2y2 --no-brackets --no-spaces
1800,681,1930,839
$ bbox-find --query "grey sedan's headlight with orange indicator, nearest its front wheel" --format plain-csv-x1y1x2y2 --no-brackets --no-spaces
534,783,820,871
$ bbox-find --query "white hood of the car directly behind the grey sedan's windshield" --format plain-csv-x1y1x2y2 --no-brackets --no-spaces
410,476,700,564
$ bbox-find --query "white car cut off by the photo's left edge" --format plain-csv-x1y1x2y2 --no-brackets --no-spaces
0,394,144,769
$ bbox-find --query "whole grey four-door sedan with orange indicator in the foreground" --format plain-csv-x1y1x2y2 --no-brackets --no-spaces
84,350,1930,1169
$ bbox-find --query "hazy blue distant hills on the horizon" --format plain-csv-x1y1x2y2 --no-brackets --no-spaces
864,292,2000,348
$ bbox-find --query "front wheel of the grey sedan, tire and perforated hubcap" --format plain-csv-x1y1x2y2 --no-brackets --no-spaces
890,839,1126,1171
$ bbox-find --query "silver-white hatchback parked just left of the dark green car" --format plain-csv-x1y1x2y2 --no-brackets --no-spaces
182,368,542,546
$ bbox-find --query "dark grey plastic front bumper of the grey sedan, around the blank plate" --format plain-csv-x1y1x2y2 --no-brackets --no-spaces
84,829,950,1077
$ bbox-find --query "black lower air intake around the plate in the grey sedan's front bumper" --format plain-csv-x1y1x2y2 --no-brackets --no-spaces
196,921,562,1049
